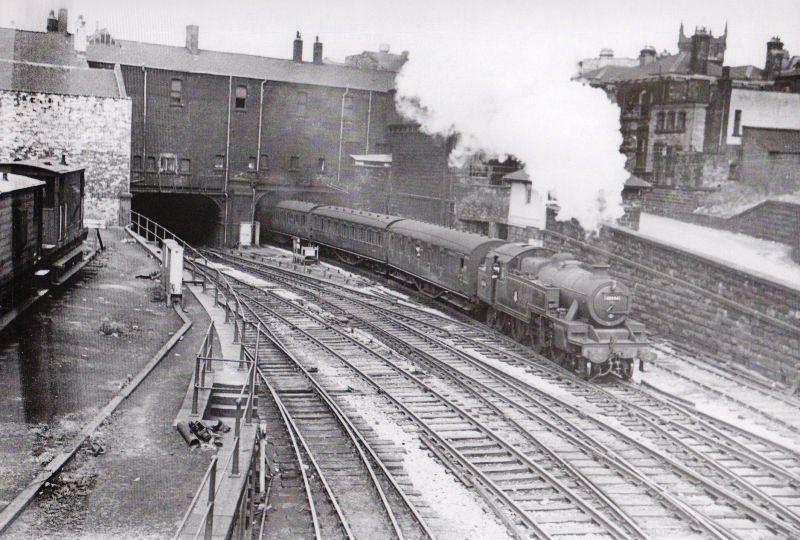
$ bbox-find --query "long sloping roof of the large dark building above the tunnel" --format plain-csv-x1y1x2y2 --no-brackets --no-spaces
86,39,395,92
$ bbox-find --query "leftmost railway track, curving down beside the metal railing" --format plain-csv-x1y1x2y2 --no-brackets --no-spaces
238,298,433,539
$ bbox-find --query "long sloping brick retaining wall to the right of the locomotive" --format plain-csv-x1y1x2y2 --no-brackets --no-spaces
545,217,800,380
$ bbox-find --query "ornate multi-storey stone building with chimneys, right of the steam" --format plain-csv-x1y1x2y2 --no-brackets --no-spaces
582,25,797,188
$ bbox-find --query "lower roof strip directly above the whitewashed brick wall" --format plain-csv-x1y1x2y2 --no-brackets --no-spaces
0,60,121,98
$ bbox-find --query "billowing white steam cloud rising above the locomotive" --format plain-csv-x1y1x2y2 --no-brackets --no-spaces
397,16,628,230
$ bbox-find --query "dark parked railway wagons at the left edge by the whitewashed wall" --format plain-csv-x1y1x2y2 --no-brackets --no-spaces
0,156,88,315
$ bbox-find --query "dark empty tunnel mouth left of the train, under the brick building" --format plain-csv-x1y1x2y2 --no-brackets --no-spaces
131,193,221,246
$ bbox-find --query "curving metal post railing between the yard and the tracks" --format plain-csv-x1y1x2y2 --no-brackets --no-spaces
129,211,261,539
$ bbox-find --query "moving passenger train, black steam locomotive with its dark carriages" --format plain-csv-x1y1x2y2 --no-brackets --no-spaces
271,201,655,379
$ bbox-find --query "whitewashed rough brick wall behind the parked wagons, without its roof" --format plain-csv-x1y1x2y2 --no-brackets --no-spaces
0,91,131,224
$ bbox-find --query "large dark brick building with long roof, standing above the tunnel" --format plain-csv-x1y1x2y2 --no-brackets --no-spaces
78,25,397,243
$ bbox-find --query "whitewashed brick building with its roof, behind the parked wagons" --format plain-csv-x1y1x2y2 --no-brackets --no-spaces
0,10,131,224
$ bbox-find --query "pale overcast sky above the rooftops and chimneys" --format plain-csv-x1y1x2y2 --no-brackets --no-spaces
0,0,800,69
